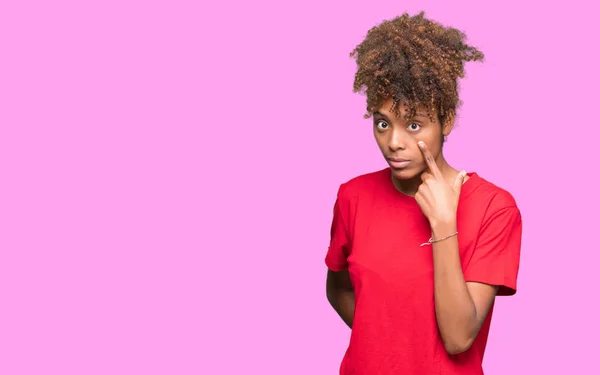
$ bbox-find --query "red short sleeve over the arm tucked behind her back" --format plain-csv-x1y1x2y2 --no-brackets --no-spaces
325,185,351,272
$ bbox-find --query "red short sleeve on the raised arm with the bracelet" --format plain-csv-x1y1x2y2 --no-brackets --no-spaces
464,206,522,296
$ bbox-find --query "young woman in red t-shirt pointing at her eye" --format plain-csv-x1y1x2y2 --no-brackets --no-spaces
325,13,522,375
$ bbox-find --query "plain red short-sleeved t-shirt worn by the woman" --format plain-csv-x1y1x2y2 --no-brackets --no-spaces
325,168,521,375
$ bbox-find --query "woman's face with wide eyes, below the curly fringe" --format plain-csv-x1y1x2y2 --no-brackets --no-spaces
373,99,453,180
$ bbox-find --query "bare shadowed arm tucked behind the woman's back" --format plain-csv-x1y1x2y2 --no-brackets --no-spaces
326,270,355,328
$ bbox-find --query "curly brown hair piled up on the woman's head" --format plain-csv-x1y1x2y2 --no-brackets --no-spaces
350,12,484,124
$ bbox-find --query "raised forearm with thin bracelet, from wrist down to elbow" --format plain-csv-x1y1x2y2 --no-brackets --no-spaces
432,223,477,354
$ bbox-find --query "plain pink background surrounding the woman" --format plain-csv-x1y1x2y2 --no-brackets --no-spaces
0,0,600,375
